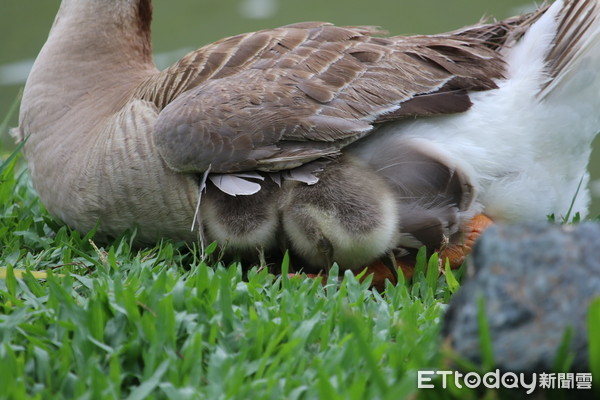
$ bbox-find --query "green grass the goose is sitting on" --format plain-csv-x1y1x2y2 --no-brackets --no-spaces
0,130,600,399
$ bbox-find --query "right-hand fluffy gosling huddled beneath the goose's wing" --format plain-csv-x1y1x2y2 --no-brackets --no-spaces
281,156,399,269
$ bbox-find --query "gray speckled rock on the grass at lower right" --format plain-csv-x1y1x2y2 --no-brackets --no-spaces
443,222,600,372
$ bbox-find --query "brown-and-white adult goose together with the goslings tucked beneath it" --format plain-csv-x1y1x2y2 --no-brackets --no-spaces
16,0,600,276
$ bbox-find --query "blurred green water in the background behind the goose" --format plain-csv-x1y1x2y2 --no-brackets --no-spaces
0,0,600,215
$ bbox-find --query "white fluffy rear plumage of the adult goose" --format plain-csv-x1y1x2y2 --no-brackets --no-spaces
360,0,600,221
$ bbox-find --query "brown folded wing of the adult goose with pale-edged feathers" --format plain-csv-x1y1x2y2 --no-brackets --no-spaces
135,21,518,173
